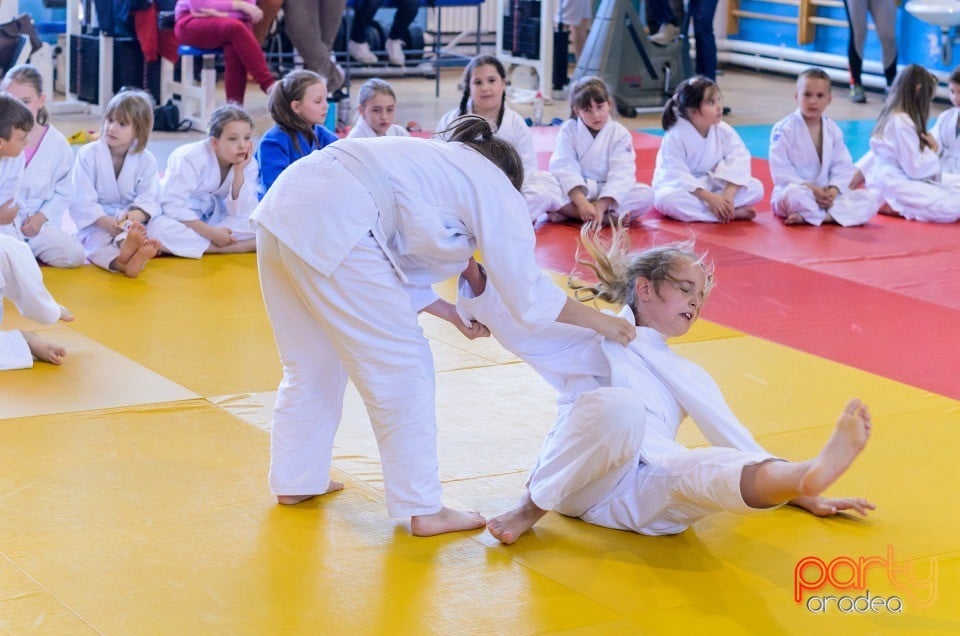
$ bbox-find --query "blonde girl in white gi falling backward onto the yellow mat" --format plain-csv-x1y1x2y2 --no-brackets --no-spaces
458,226,874,544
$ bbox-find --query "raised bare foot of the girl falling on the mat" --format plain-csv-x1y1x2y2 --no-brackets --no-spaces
800,399,870,496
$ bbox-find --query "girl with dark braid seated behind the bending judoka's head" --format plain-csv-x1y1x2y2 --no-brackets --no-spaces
435,55,537,191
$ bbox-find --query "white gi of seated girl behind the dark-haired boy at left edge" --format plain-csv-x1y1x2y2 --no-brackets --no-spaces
0,126,86,267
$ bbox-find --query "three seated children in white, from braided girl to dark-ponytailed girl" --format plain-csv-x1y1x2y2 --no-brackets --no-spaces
428,55,763,222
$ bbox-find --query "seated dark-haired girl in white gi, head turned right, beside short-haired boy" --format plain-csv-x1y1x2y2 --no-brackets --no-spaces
653,75,763,223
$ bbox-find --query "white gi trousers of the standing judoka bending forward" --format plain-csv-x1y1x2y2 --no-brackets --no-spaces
257,227,442,517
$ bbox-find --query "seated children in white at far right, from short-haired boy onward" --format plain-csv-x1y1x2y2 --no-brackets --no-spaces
770,65,960,225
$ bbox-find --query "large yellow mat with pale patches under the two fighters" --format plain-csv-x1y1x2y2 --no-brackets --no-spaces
0,255,960,636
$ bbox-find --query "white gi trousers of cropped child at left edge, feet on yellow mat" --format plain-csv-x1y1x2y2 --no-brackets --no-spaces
0,234,61,371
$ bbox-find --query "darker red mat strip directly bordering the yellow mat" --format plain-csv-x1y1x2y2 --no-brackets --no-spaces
537,224,960,399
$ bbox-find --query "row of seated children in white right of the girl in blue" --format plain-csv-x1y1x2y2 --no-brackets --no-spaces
275,55,960,226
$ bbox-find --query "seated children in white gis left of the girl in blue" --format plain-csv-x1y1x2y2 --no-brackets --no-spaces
0,65,257,277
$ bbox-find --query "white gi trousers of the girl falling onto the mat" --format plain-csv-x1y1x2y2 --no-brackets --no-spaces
528,388,773,535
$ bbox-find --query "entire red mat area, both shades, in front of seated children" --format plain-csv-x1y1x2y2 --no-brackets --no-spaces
537,126,960,399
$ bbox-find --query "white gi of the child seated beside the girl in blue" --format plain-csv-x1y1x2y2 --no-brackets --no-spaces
147,138,258,258
